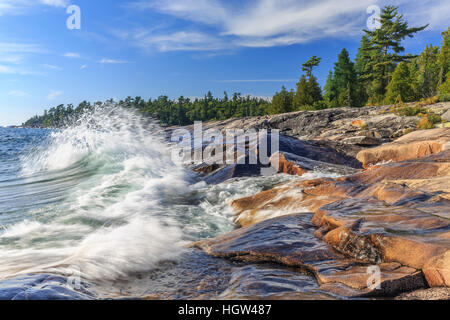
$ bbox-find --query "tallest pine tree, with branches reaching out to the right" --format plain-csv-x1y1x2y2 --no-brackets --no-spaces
363,6,428,103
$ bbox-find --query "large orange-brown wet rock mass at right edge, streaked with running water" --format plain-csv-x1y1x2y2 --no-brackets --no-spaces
232,150,450,287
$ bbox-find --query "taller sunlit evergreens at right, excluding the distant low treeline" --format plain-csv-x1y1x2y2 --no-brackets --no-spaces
269,6,450,113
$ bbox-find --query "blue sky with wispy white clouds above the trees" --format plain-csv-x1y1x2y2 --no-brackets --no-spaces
0,0,450,126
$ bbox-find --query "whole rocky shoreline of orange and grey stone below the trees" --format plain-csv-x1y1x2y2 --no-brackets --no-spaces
174,103,450,299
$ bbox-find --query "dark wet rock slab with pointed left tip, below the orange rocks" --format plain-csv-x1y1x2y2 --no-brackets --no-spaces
194,213,426,298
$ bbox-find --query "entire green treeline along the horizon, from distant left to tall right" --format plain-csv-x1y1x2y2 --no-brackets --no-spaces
24,6,450,127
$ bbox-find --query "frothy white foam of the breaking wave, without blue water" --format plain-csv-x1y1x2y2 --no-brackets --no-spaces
0,105,192,279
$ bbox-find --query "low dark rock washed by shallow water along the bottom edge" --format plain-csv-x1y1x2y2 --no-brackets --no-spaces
110,249,344,300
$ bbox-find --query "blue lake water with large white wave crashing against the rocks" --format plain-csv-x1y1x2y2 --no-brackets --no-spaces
0,105,324,297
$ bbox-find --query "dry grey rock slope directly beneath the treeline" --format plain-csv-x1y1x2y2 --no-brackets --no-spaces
163,102,450,168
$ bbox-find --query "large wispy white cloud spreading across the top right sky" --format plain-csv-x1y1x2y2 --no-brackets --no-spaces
129,0,450,51
